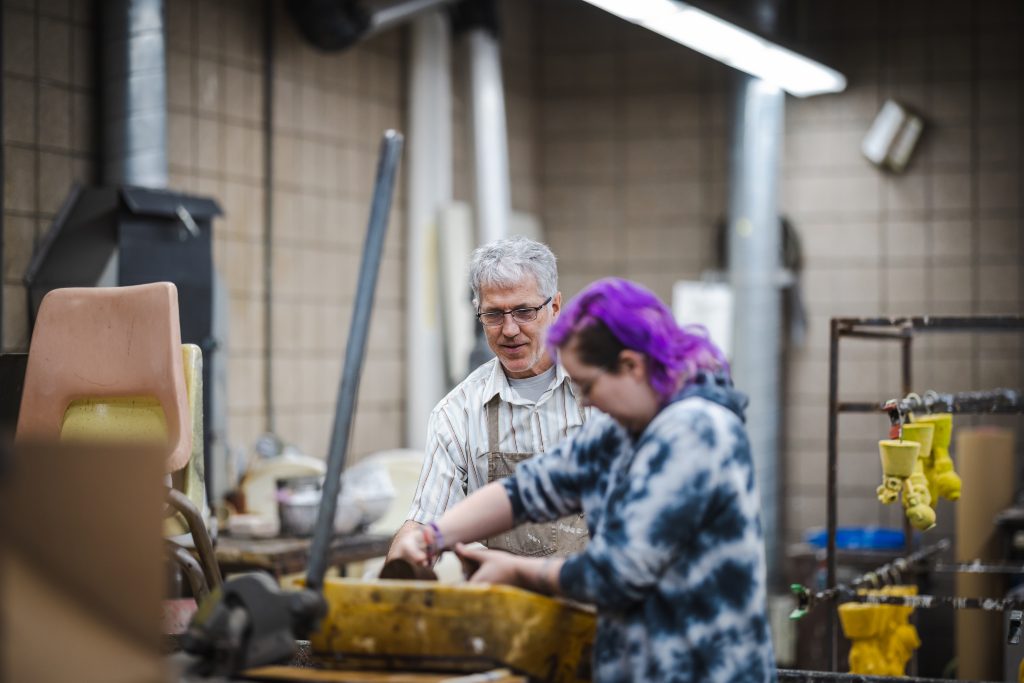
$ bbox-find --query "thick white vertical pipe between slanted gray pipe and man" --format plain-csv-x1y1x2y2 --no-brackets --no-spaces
406,11,455,450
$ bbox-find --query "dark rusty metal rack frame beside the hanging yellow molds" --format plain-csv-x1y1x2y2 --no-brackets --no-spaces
825,315,1024,672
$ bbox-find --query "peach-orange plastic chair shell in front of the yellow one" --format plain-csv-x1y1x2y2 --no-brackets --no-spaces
15,283,193,472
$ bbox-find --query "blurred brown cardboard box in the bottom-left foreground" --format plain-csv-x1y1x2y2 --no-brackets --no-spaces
0,444,165,683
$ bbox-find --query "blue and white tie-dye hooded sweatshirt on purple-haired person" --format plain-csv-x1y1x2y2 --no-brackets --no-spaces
505,374,775,683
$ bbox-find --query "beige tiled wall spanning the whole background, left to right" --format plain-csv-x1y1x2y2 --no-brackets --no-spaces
2,0,1024,539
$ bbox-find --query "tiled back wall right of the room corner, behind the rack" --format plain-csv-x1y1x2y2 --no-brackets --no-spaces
540,0,1024,540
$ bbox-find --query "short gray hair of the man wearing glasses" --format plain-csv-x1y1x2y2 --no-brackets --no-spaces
469,236,558,307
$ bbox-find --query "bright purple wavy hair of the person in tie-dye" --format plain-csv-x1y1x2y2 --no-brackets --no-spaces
548,278,729,400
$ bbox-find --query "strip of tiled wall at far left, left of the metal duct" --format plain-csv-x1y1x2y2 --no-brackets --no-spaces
0,0,96,351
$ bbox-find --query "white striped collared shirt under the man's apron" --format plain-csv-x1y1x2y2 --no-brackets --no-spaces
409,358,592,524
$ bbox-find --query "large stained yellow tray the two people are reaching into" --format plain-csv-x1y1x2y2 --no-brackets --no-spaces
299,579,597,683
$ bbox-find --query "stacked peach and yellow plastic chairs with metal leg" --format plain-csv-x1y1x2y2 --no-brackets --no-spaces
14,283,221,597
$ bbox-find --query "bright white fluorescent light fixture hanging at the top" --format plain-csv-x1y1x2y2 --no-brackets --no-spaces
587,0,846,97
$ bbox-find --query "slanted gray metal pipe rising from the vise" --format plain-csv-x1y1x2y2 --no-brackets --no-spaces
306,130,402,592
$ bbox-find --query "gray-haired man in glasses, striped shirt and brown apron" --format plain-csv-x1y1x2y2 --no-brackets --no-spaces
391,237,590,556
